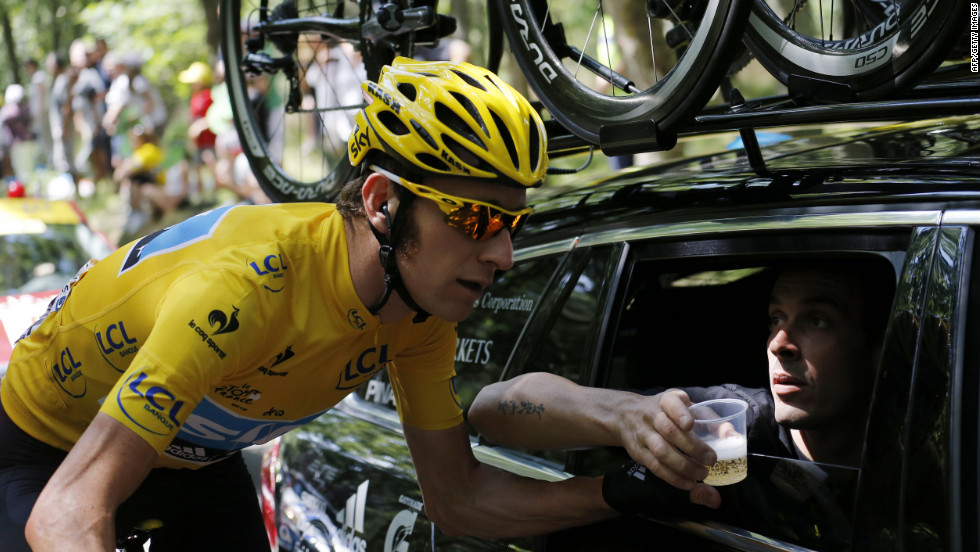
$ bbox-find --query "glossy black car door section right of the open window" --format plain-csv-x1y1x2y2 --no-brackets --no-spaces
856,217,980,551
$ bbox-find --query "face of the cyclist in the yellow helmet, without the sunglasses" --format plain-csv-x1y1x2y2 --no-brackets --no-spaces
399,178,526,322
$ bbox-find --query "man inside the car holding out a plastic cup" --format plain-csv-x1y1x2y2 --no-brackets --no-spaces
468,260,895,512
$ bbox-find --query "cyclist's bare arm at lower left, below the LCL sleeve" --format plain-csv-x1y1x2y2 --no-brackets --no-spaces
26,413,157,552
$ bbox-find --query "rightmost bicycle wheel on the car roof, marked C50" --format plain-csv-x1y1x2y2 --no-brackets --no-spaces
745,0,966,101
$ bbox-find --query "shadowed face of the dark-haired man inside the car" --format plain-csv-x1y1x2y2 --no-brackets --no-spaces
767,270,877,430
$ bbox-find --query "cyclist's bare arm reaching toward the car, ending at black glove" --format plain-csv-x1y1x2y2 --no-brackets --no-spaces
404,423,618,538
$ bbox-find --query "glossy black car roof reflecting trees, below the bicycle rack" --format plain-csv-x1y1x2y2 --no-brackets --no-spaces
521,116,980,242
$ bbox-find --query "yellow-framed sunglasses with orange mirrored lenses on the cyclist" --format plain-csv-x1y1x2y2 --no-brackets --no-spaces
371,165,533,240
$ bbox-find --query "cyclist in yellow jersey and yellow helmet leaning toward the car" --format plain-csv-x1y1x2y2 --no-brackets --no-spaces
0,58,615,550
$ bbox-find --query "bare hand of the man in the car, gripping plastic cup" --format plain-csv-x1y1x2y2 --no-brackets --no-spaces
620,389,720,492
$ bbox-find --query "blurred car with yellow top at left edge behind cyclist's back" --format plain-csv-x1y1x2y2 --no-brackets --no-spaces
0,197,115,377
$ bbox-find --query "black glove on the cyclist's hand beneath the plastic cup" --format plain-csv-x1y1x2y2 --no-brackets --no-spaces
602,462,691,515
